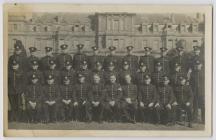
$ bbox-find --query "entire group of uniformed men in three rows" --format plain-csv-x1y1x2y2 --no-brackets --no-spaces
8,40,205,127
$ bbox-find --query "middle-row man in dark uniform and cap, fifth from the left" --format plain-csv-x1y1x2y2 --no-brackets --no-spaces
77,60,92,83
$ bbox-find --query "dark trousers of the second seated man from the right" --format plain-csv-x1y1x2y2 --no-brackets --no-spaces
156,105,172,124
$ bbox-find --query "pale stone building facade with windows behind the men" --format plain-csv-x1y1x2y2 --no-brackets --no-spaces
8,13,205,56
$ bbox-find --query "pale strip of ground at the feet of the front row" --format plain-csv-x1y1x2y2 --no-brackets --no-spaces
9,122,204,130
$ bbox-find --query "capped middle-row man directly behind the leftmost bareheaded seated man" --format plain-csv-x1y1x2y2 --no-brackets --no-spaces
91,61,104,84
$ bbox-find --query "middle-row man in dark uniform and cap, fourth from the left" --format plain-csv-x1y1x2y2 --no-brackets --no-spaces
60,60,77,84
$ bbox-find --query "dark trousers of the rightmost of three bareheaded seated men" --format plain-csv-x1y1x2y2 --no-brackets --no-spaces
121,102,137,120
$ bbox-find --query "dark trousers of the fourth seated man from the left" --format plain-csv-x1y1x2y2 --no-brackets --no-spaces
74,101,92,121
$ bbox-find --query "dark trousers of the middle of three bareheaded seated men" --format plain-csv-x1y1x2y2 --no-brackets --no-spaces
104,102,122,121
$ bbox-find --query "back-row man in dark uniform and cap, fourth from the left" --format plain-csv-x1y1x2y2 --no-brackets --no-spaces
56,44,72,70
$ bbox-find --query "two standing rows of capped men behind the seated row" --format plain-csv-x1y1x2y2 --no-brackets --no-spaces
8,41,204,126
